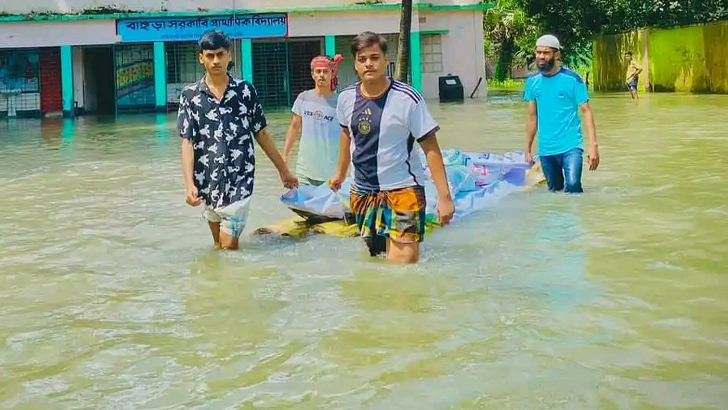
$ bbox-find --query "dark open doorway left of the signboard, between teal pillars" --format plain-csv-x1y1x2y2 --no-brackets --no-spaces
83,46,116,115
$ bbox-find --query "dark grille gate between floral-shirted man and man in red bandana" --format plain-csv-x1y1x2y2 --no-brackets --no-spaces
253,38,323,110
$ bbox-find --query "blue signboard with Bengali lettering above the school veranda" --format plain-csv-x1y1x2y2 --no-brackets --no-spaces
116,13,288,43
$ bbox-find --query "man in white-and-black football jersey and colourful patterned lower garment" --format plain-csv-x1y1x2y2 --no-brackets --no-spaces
330,31,455,263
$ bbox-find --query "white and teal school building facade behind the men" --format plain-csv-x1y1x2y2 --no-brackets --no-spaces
0,0,487,117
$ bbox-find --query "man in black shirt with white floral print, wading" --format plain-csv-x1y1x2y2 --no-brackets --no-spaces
177,30,298,249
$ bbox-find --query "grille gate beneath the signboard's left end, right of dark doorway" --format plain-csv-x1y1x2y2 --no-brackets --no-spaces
114,44,155,112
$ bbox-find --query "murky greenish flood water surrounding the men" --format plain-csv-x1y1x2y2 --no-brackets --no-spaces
0,94,728,410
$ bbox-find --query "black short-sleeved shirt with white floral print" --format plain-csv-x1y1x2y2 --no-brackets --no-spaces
177,77,267,208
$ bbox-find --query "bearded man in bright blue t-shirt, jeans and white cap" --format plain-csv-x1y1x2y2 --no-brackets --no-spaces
523,35,599,193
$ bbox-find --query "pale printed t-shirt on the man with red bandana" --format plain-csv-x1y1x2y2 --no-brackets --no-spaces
291,90,341,181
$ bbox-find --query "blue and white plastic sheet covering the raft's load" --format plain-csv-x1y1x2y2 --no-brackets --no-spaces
281,149,531,221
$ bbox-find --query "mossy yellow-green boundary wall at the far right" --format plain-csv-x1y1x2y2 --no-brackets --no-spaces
593,21,728,93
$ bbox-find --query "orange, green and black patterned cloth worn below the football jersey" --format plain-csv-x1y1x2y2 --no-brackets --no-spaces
350,186,426,254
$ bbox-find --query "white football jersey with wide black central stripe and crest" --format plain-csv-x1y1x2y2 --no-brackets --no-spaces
336,80,440,191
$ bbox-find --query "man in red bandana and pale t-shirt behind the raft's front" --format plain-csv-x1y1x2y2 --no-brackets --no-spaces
283,55,343,185
